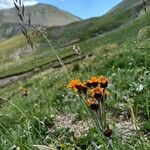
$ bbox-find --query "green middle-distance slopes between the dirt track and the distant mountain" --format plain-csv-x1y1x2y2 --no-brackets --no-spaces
0,1,150,76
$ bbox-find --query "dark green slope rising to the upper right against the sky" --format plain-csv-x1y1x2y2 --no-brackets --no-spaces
47,0,150,46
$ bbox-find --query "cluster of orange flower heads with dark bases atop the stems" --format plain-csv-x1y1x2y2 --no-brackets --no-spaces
67,76,109,111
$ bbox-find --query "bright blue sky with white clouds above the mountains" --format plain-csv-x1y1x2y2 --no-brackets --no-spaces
0,0,122,19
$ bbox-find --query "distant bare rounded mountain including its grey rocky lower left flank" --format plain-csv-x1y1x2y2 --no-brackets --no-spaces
0,4,81,38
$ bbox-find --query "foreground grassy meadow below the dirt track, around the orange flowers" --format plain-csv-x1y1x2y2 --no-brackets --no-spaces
0,27,150,150
